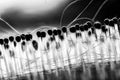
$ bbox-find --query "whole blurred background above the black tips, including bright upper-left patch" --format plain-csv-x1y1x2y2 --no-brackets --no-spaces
0,0,120,33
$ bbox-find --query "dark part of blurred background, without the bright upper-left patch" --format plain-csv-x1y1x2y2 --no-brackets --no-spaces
0,0,120,32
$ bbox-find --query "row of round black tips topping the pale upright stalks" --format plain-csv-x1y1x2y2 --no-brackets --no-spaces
0,17,120,48
